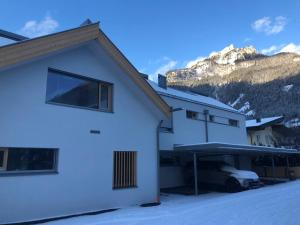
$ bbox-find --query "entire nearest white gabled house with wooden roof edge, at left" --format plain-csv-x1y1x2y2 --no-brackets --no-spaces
0,23,170,224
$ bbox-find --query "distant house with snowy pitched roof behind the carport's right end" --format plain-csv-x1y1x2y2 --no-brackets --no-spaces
246,116,284,147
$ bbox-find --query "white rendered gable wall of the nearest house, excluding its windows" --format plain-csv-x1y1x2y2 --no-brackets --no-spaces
0,41,161,224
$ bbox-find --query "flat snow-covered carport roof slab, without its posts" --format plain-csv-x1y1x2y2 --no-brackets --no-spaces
174,142,300,155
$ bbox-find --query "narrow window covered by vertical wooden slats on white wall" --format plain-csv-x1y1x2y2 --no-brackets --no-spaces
113,151,137,189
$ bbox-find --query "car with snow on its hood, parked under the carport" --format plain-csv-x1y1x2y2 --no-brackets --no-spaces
187,161,262,192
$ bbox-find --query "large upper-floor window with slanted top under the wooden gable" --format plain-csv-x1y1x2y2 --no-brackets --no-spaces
46,70,112,111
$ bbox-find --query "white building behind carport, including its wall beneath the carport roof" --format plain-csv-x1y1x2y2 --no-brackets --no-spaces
148,76,251,188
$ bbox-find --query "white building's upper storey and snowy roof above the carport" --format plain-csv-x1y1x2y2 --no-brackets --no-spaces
148,76,247,151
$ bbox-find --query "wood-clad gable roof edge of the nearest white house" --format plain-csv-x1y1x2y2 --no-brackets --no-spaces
0,23,170,116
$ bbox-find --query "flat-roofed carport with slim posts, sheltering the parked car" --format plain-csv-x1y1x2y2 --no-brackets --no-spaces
174,142,300,195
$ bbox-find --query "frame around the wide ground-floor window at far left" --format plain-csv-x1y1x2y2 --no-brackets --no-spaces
0,147,59,176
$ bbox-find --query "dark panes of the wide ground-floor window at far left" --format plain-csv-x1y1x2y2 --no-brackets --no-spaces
0,148,57,172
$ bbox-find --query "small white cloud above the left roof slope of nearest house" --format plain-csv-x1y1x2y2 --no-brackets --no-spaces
20,15,59,37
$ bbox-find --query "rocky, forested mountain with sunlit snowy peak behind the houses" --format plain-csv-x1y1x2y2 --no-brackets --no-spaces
166,45,300,124
